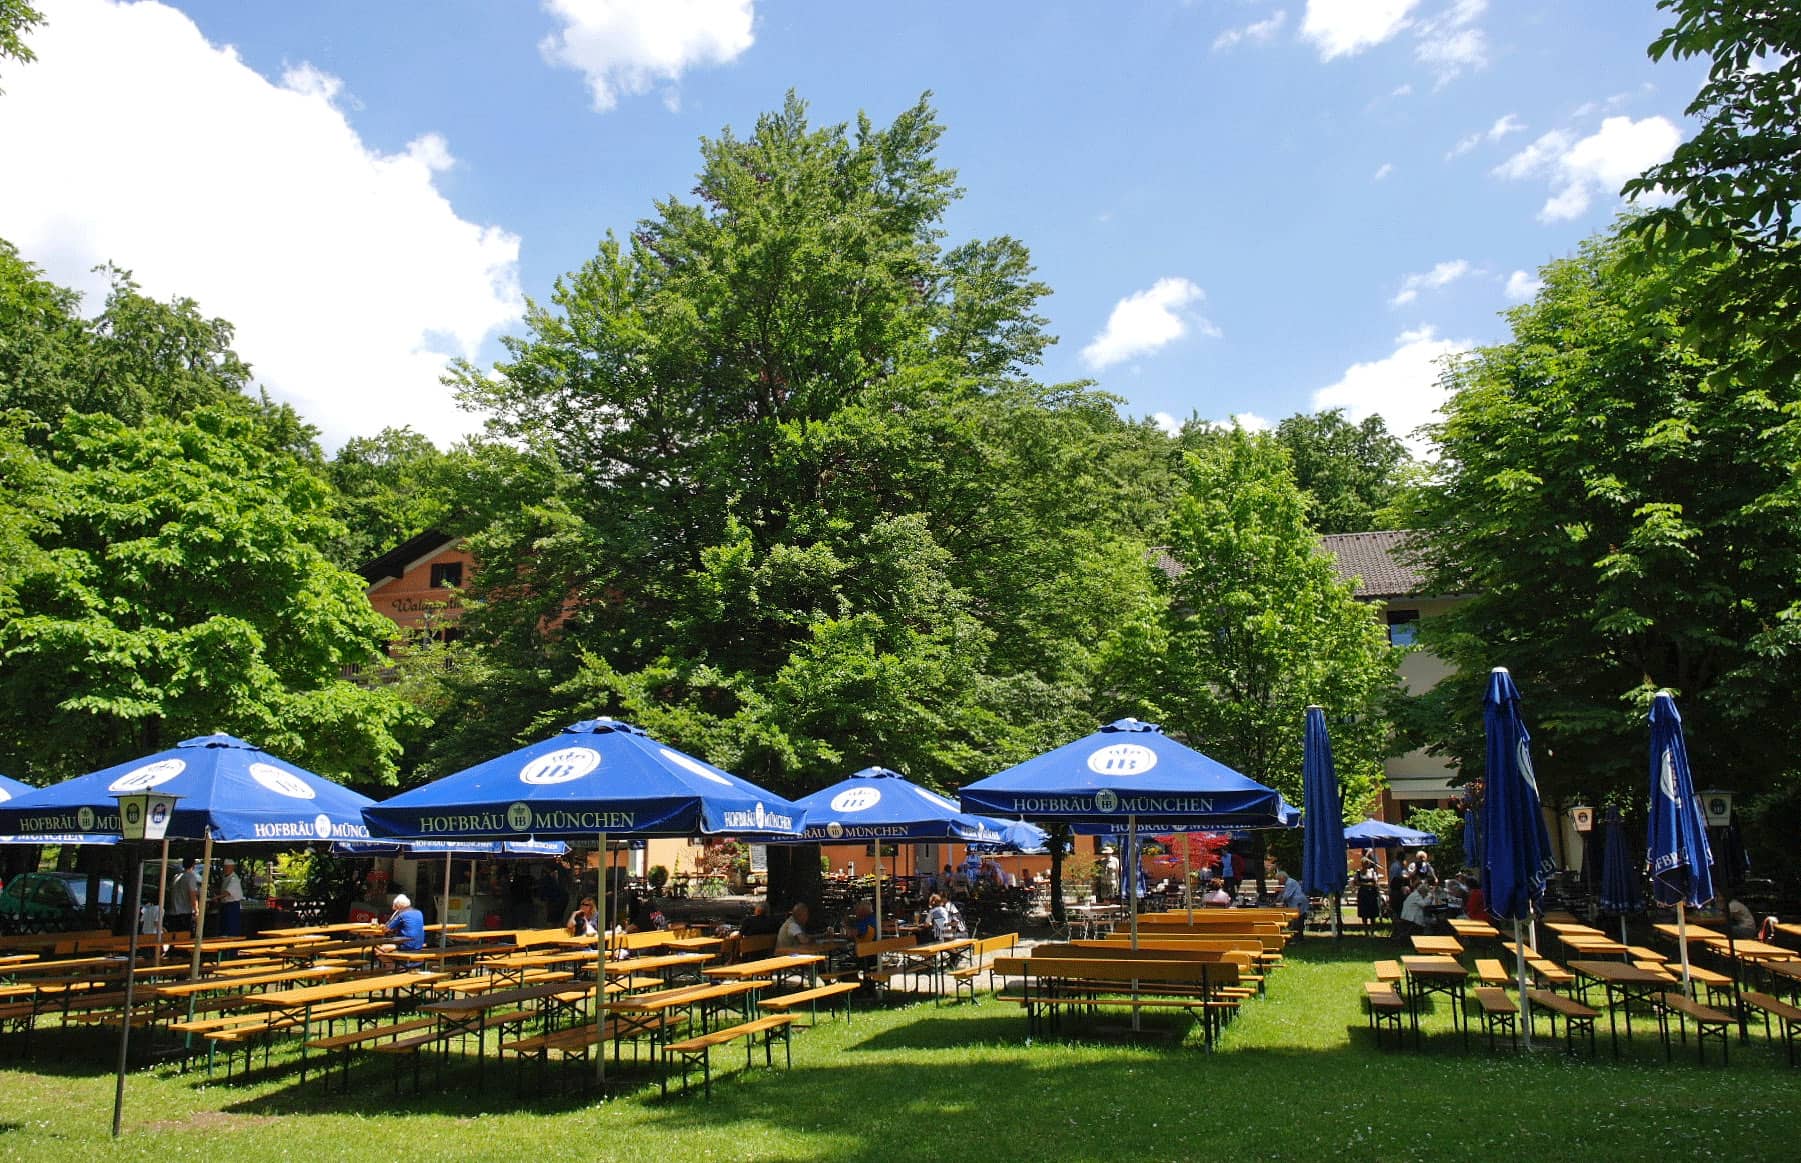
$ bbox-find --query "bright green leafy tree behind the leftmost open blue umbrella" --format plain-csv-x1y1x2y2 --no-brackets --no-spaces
0,407,411,783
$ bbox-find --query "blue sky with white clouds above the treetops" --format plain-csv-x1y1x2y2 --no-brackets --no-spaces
0,0,1702,446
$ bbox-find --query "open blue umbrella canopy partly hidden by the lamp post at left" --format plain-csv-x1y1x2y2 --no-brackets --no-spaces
0,735,375,844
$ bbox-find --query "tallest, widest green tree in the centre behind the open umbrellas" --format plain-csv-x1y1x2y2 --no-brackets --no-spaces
436,99,1154,802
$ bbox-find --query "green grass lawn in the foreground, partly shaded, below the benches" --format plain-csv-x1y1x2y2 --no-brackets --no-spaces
0,938,1801,1163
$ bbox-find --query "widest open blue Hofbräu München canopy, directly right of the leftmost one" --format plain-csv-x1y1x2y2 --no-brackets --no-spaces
364,718,801,841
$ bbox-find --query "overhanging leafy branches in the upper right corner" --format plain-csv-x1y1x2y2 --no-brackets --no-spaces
1625,0,1801,380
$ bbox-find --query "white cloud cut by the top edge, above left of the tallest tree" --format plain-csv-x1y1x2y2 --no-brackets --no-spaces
538,0,756,113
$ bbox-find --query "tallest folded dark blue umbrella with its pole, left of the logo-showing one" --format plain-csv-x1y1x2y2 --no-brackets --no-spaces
1482,666,1554,1044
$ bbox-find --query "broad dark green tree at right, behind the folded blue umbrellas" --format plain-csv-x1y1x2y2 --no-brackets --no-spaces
1410,229,1801,838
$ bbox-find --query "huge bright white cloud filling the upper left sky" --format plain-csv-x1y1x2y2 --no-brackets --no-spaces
0,0,522,445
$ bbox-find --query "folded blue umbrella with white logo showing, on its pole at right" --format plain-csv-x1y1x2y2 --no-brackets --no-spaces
1644,691,1713,992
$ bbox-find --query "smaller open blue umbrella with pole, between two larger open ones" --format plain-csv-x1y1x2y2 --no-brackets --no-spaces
794,767,1007,933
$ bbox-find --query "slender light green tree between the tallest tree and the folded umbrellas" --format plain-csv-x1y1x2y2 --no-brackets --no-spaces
1135,427,1398,805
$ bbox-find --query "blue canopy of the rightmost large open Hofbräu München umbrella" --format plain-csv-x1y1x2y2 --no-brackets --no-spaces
962,718,1284,832
